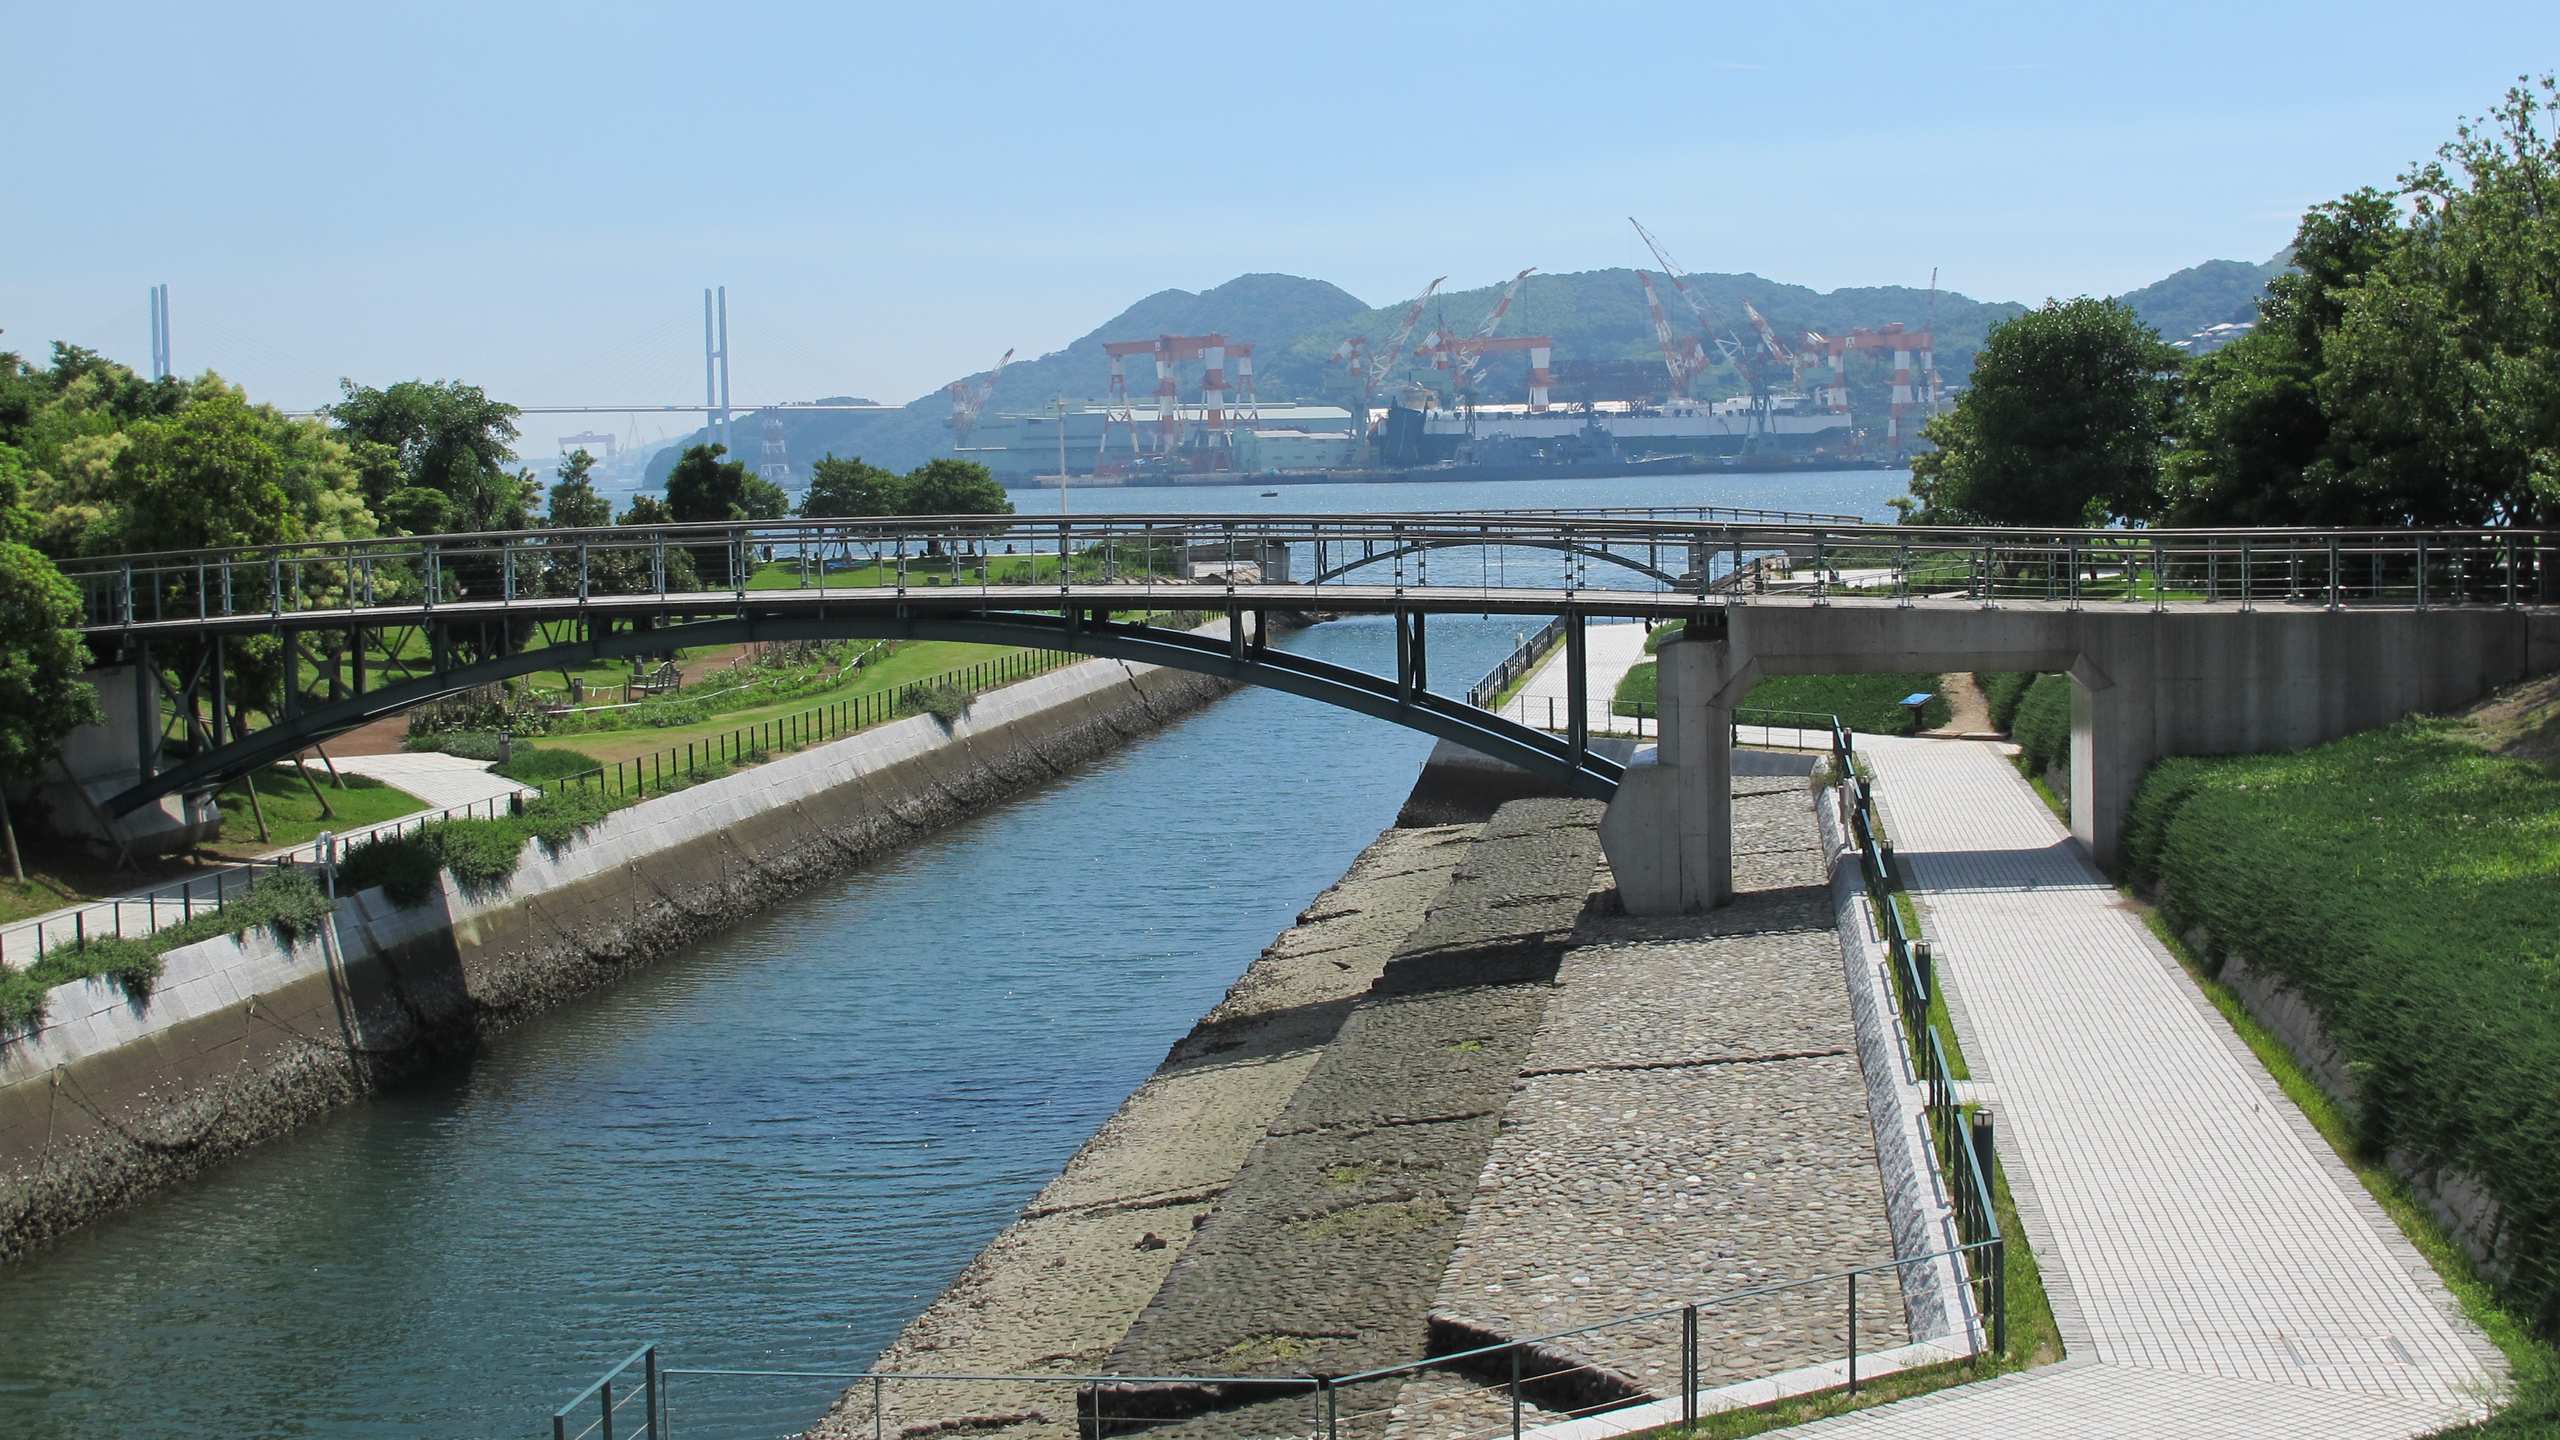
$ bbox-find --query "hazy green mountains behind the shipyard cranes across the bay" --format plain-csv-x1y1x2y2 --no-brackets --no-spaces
648,256,2286,487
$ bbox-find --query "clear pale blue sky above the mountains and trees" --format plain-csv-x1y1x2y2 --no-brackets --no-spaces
0,0,2560,454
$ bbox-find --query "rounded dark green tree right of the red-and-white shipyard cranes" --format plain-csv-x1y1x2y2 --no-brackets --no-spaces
1912,297,2179,528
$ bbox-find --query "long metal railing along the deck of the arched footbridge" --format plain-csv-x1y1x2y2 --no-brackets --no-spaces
64,510,2560,630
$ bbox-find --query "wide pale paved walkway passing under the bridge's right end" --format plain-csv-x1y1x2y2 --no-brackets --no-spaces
1800,735,2504,1440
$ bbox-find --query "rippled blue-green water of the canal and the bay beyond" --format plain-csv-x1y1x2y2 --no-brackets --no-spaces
0,471,1905,1440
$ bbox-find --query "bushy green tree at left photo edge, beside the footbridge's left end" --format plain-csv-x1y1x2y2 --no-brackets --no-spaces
0,541,102,881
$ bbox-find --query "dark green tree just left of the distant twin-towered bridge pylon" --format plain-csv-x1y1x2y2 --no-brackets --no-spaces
328,379,532,536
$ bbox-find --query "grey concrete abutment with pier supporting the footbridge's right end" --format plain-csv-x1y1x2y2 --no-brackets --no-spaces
1600,605,2560,891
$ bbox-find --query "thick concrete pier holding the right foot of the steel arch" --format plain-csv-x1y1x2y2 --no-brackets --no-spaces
1600,638,1733,915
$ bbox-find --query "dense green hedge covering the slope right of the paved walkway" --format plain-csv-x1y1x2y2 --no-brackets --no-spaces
2125,720,2560,1338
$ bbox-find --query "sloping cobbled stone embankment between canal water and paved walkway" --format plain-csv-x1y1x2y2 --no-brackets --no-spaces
817,761,1910,1440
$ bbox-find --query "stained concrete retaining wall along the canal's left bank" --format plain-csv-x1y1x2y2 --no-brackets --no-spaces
0,648,1229,1261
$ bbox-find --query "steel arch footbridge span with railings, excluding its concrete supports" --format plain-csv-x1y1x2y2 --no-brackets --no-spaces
61,510,2560,815
